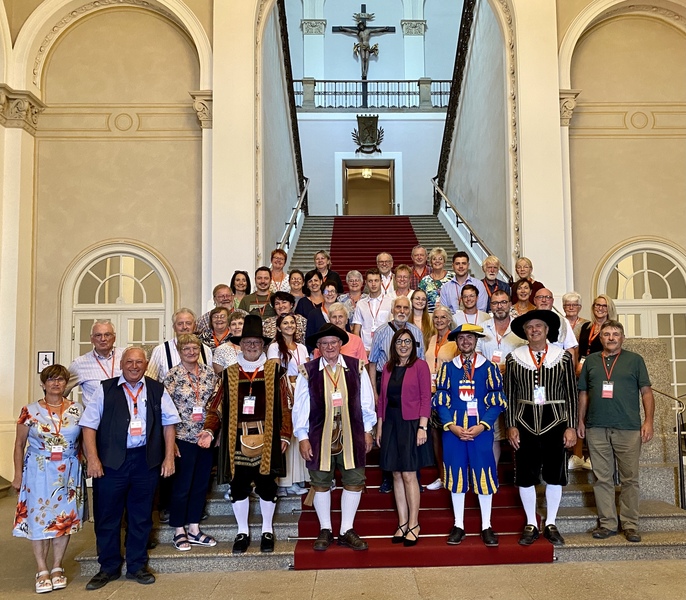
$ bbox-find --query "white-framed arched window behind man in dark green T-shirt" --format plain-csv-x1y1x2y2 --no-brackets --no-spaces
598,241,686,397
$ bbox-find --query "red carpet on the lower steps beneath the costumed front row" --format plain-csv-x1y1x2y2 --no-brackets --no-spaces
294,453,553,570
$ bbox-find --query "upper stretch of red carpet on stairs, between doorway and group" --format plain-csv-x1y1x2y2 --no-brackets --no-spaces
331,216,419,289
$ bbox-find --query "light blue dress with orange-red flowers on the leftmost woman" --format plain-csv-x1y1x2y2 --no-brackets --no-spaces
12,402,86,540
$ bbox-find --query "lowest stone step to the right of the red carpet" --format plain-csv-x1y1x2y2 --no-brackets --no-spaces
556,531,686,562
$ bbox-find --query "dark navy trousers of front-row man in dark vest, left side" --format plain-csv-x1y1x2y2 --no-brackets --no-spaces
93,446,160,573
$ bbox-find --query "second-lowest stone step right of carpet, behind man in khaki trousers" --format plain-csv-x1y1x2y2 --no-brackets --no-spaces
543,500,686,539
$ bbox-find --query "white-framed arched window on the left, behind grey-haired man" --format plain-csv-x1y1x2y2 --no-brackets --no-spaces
61,244,174,364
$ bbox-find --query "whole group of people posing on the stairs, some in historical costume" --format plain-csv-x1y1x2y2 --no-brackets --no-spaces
12,246,654,593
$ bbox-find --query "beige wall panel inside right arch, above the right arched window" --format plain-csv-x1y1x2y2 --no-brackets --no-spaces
570,15,686,306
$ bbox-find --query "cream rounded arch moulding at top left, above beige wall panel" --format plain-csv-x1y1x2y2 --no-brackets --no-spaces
8,0,212,98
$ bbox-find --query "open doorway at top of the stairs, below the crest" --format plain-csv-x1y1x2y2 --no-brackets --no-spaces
343,161,396,215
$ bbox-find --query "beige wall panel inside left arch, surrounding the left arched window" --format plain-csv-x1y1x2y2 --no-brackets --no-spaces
33,8,201,370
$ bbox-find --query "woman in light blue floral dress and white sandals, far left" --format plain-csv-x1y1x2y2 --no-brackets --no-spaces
12,365,85,594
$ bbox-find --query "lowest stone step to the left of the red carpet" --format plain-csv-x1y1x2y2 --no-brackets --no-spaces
76,534,295,576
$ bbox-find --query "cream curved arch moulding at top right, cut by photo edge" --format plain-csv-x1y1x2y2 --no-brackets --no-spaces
558,0,686,90
